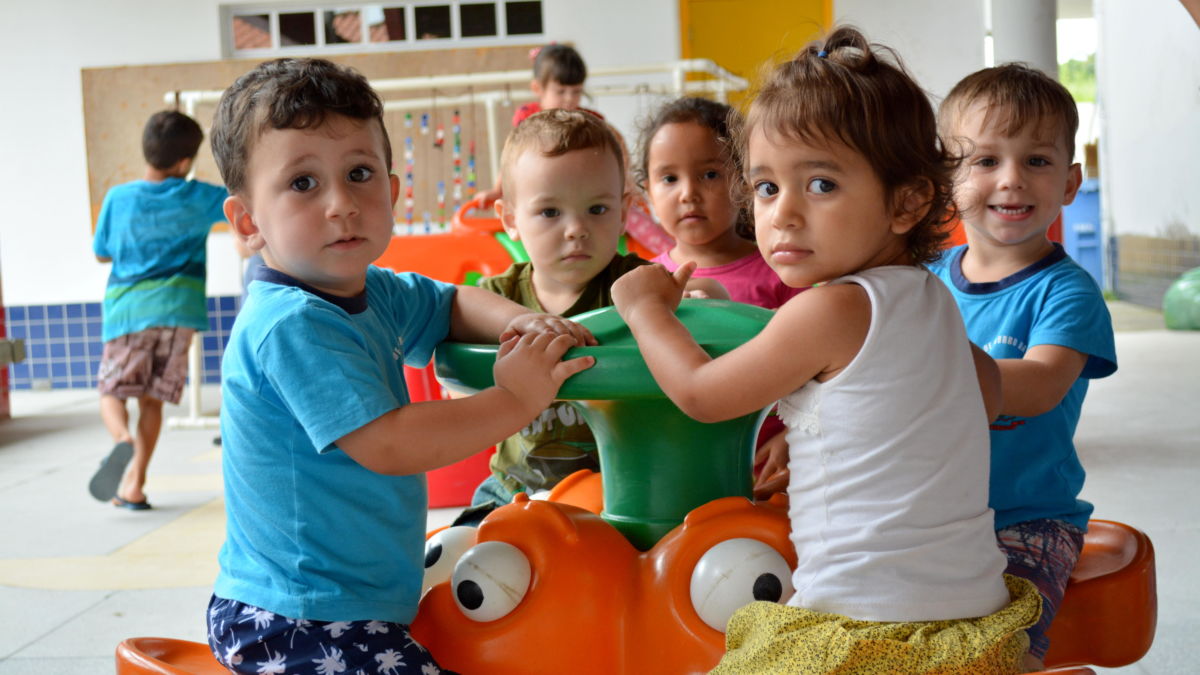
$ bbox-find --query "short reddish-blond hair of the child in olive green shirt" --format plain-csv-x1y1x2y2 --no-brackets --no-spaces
500,108,625,196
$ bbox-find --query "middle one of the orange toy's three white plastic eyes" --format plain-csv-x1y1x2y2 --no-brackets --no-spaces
450,542,533,622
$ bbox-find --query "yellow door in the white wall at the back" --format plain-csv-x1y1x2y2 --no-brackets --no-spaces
679,0,833,104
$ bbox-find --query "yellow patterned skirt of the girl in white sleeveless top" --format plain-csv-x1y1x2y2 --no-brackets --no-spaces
713,574,1042,675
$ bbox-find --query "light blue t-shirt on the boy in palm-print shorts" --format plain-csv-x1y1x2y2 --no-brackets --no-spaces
214,267,455,623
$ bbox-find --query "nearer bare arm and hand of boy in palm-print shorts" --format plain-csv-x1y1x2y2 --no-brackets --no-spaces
337,333,595,476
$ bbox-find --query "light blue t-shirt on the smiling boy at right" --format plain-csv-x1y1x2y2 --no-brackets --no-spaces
930,244,1117,530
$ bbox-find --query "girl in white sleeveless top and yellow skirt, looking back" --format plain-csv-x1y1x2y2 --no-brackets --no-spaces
613,28,1040,674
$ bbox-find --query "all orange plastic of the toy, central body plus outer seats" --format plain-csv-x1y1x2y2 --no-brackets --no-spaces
116,521,1158,675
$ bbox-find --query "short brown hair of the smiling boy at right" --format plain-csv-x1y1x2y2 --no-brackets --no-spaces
938,62,1079,162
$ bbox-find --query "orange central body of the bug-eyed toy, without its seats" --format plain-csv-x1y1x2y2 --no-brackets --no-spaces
412,487,796,675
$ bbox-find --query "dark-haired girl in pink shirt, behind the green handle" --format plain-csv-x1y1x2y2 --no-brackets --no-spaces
636,97,803,310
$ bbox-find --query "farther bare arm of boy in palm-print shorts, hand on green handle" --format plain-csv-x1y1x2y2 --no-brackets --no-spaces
448,286,596,346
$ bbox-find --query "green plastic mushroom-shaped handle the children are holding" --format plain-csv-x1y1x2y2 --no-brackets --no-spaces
437,299,772,550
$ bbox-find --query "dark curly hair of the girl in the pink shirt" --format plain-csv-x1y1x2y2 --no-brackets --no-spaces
634,96,754,241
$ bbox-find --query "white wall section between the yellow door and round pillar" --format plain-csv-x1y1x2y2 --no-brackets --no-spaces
833,0,984,99
